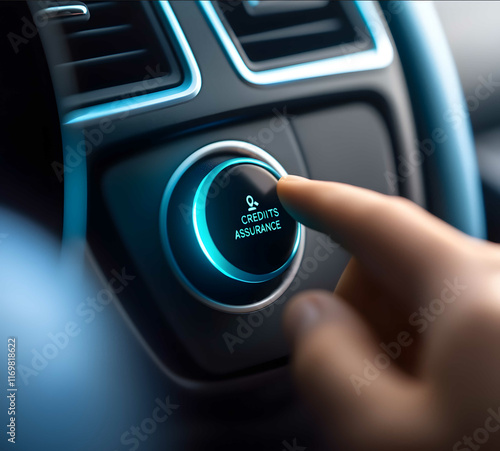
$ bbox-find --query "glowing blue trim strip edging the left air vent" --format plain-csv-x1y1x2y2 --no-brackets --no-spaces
64,1,201,125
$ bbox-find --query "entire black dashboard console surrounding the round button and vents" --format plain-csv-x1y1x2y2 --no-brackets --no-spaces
32,1,424,381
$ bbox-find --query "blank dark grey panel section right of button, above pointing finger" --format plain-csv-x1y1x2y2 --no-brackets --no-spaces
292,103,398,189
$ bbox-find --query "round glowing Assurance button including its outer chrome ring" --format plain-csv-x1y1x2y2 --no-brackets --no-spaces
159,141,305,313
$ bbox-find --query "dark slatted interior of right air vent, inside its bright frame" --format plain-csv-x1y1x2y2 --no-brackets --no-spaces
213,0,373,70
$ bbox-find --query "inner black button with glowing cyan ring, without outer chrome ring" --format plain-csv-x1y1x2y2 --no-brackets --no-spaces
193,158,300,283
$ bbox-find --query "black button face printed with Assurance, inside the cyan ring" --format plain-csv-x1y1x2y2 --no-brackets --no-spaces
206,164,297,274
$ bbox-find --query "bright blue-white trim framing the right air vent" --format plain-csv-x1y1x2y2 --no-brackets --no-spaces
199,1,394,85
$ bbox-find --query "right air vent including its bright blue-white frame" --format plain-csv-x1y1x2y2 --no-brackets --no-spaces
199,0,394,84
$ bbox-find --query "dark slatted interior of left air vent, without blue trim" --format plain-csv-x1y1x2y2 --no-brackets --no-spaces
54,1,182,104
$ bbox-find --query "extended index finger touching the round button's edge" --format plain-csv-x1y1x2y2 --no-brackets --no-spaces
278,176,474,308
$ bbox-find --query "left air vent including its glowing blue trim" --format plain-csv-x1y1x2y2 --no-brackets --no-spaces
35,0,201,125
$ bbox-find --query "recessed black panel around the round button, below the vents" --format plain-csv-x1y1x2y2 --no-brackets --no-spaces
97,103,393,375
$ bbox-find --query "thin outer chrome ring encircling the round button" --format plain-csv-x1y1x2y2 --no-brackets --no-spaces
159,141,306,313
